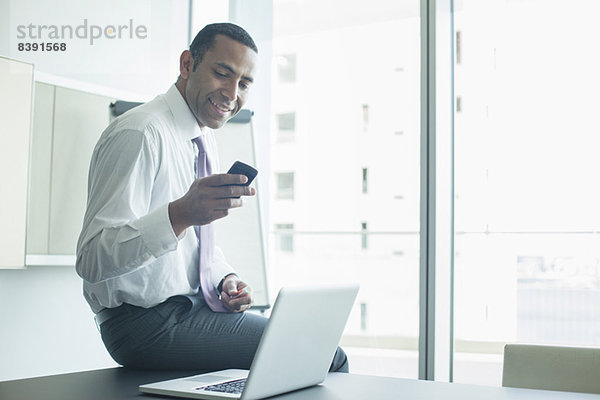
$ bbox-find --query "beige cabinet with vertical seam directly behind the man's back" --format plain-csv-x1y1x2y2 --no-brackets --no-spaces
27,82,114,263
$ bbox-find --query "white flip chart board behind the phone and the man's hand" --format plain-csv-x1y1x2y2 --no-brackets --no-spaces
213,115,270,309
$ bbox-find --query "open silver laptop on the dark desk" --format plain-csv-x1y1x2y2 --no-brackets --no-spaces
139,285,358,400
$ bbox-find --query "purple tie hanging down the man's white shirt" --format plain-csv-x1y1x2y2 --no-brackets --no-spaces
193,137,227,312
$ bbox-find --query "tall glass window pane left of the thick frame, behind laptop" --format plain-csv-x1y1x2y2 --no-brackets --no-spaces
270,0,421,377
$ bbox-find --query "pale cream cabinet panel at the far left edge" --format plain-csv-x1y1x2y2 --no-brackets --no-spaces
0,57,33,268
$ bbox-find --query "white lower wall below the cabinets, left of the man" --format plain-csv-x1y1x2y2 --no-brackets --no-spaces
0,266,116,381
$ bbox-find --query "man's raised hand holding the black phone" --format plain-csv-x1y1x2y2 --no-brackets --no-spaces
169,174,256,236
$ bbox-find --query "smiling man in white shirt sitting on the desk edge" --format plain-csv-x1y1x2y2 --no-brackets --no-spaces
76,23,348,372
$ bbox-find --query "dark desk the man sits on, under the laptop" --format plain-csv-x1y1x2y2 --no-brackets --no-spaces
0,368,600,400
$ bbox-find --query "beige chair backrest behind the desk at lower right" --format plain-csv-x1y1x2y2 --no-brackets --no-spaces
502,344,600,393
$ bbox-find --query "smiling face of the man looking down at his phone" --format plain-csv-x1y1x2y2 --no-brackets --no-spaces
181,35,256,129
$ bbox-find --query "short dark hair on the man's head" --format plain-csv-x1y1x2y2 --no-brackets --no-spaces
190,22,258,71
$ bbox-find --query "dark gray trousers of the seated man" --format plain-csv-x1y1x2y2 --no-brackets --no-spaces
100,296,348,372
